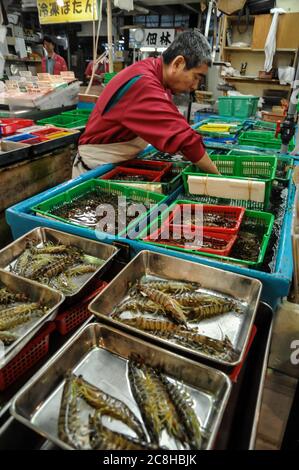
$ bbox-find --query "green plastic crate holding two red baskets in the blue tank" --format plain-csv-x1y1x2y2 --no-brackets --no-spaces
137,209,275,268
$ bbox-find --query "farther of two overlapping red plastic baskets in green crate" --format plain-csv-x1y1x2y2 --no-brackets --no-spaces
165,204,245,235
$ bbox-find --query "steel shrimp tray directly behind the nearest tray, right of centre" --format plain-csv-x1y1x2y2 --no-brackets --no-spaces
89,251,262,368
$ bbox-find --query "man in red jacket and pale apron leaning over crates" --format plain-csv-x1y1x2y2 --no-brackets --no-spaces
73,31,218,178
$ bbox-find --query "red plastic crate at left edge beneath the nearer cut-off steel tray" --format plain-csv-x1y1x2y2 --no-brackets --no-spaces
0,322,55,391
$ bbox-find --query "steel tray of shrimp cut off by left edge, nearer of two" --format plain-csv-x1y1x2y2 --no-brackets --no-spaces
0,269,64,368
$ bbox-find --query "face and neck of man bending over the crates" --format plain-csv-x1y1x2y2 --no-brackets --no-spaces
167,56,209,94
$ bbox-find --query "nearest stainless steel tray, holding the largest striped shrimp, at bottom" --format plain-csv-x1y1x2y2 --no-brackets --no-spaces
11,323,231,449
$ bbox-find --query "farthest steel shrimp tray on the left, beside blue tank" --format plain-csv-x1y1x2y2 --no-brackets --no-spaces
0,227,119,301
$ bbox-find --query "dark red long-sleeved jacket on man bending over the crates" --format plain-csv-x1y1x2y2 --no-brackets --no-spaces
79,58,205,162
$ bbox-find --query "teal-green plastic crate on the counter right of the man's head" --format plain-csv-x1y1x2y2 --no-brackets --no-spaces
218,96,259,118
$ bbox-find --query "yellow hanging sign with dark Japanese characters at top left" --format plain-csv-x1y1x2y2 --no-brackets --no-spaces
37,0,98,24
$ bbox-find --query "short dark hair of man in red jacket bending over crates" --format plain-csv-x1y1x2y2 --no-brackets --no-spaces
162,31,211,70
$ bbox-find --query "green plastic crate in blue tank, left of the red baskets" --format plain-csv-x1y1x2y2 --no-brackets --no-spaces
31,179,166,236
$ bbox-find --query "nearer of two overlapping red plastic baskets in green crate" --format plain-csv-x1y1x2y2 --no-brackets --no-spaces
143,224,237,256
